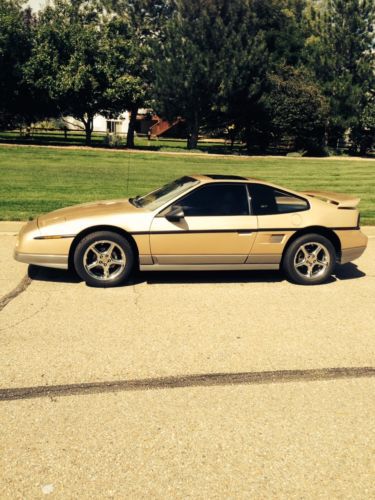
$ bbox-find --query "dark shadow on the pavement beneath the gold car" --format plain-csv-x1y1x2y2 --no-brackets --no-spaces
28,262,366,286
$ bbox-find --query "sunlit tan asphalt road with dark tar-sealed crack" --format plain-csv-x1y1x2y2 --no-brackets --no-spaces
0,227,375,499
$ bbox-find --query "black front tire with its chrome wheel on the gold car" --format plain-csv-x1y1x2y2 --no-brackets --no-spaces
74,231,135,288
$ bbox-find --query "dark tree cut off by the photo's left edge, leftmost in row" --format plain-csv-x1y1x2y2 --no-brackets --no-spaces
0,0,33,127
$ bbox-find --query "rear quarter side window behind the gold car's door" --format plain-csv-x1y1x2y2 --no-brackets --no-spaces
250,184,309,215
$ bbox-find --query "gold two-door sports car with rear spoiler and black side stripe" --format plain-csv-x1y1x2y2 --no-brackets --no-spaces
14,174,367,287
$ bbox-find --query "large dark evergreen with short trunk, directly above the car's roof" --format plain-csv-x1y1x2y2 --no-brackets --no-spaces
155,0,268,149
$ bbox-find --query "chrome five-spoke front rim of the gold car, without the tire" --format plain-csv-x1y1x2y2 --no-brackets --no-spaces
83,240,126,281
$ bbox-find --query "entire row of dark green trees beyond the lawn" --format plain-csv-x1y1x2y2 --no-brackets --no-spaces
0,0,375,154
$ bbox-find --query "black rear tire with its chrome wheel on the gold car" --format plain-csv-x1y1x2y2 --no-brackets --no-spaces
281,233,336,285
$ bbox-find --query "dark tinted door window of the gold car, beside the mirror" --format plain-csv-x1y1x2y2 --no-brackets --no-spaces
176,184,249,217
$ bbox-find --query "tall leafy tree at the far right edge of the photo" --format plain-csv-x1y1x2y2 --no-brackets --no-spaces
305,0,375,145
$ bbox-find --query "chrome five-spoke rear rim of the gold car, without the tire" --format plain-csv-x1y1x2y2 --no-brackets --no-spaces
294,241,331,279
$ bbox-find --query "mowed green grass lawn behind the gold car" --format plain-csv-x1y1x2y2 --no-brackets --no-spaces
0,146,375,224
